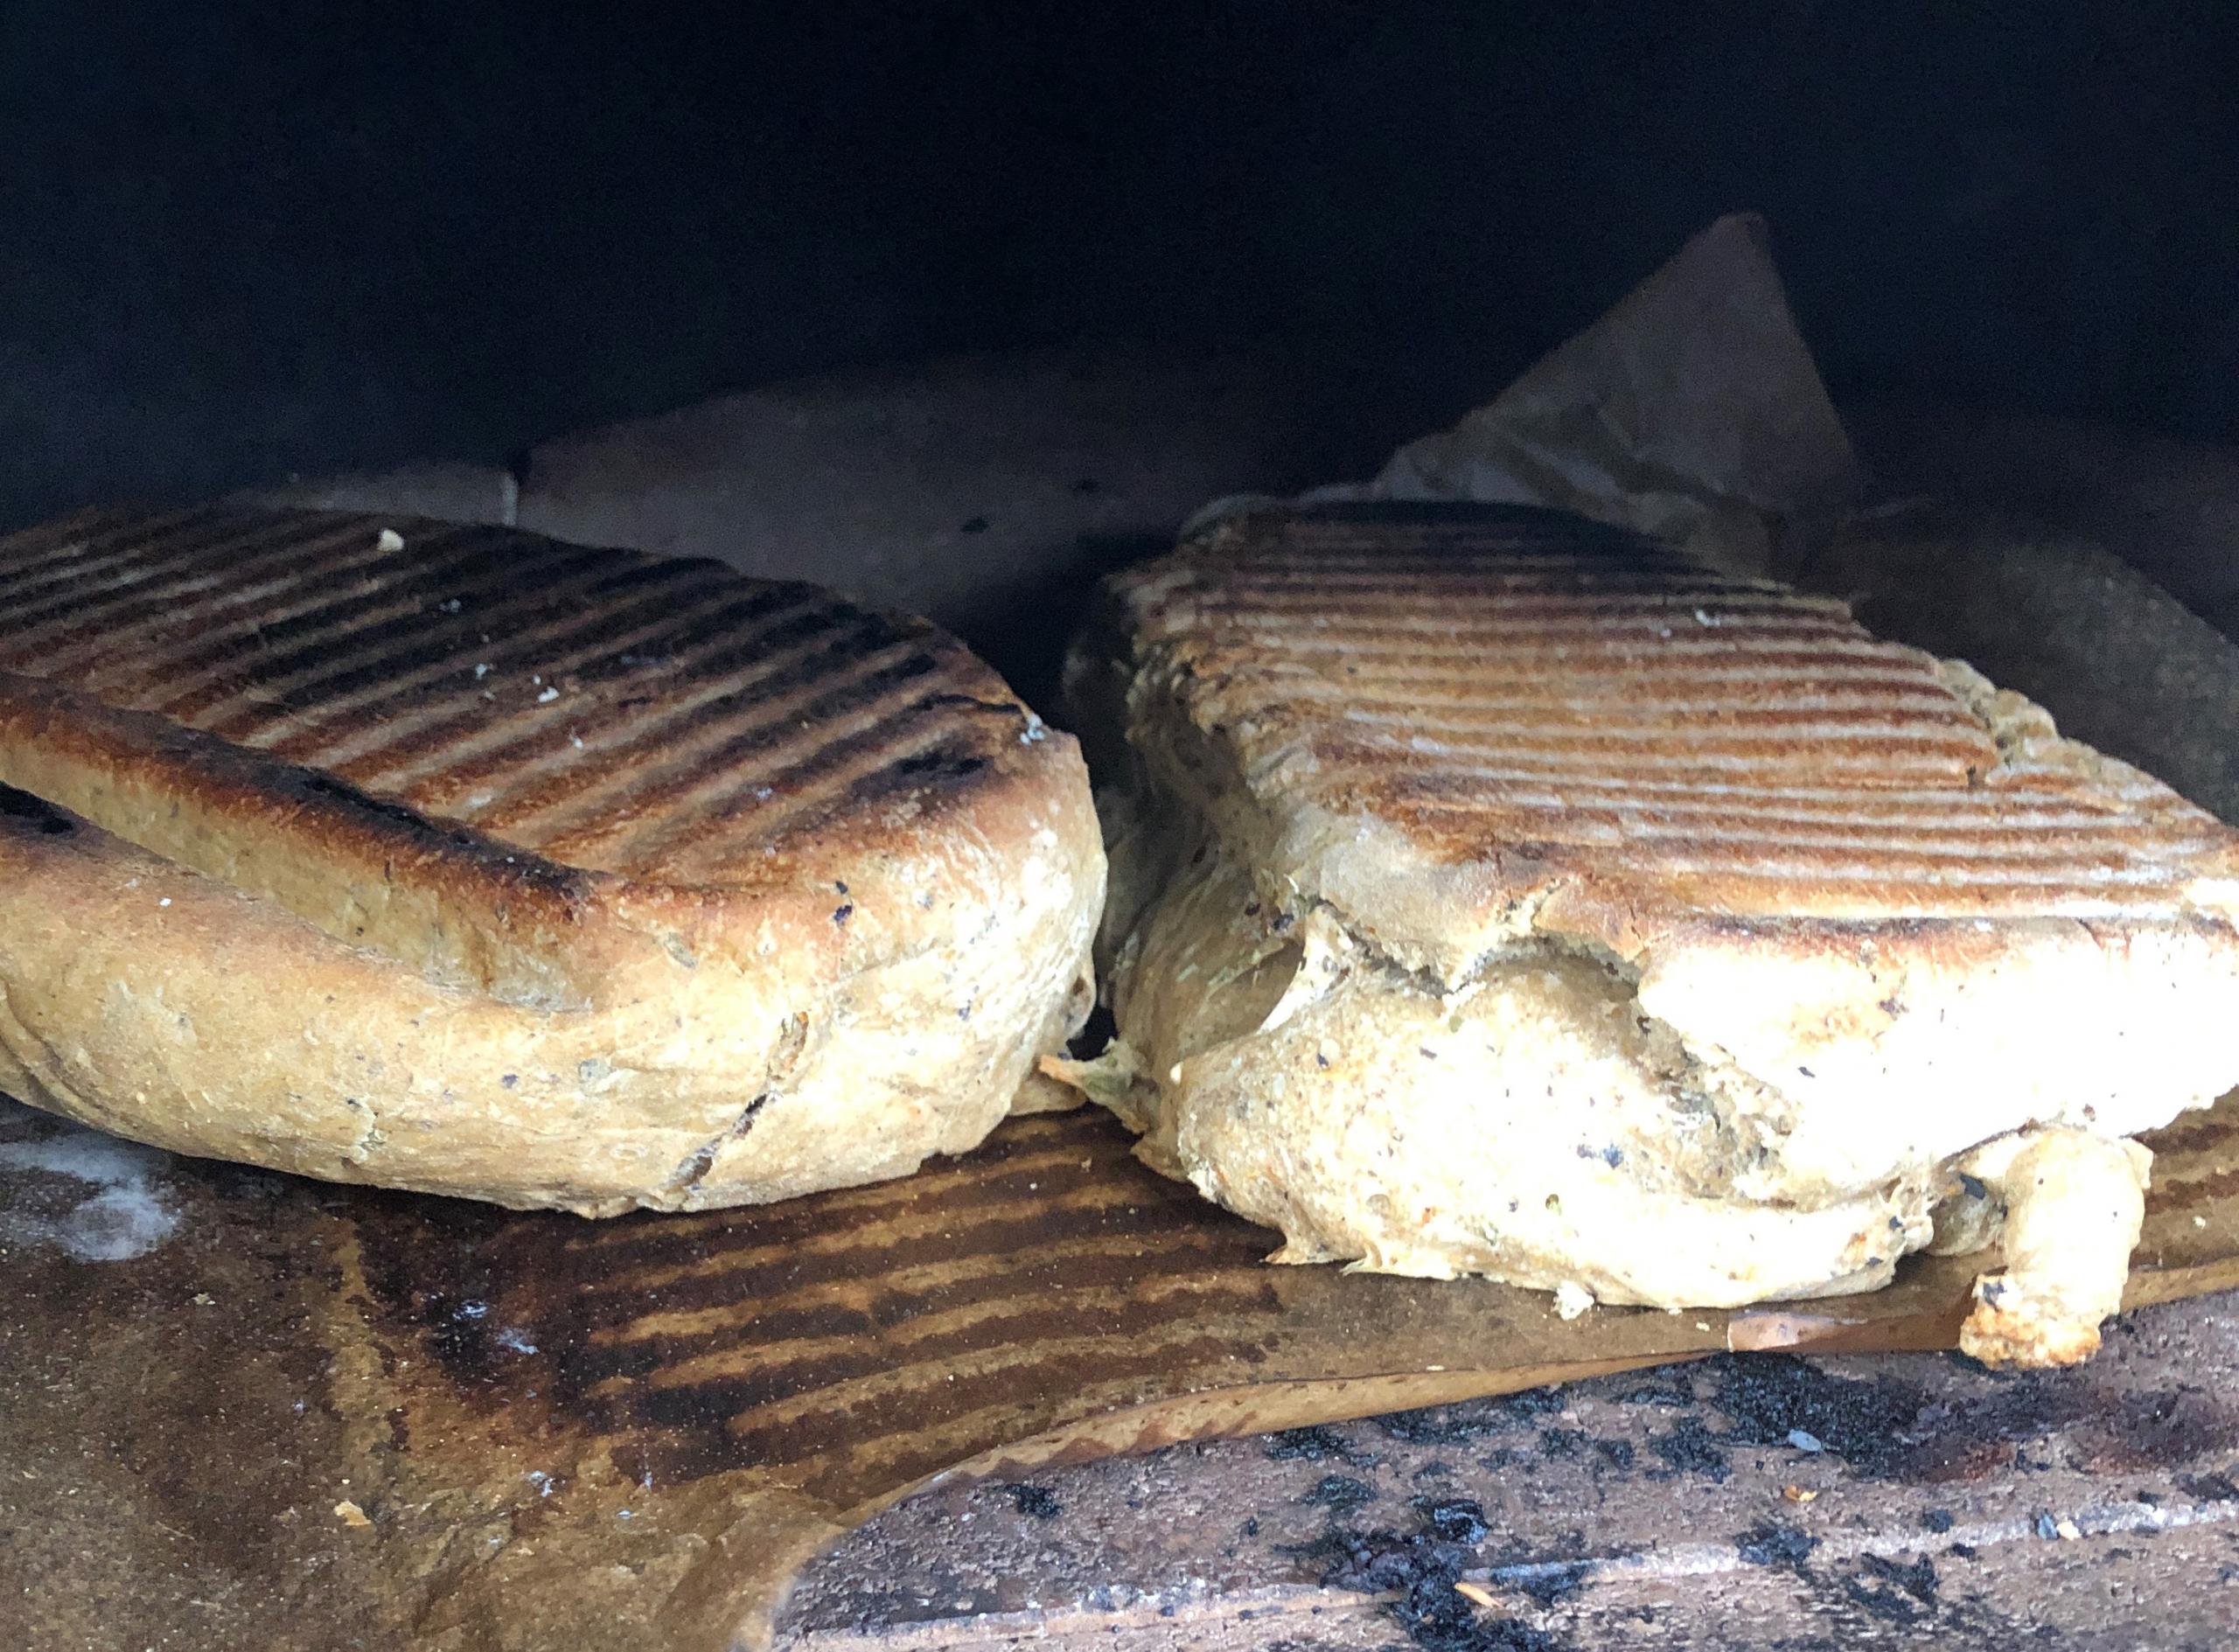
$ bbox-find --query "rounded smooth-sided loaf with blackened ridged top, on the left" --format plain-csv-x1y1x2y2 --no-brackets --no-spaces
0,501,1104,1216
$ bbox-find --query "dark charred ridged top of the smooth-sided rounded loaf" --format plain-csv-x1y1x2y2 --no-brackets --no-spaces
0,511,1048,882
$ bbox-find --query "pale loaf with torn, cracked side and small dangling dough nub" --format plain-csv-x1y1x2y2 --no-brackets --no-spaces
1061,505,2239,1363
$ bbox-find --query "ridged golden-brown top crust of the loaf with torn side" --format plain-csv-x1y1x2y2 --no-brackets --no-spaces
1097,494,2239,979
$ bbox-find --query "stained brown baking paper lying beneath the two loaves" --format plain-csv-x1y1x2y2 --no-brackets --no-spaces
0,1092,2239,1652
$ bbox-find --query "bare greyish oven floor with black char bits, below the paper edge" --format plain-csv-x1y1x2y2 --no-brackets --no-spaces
784,1296,2239,1652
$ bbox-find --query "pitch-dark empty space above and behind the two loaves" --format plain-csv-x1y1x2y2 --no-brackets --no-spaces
0,0,2239,519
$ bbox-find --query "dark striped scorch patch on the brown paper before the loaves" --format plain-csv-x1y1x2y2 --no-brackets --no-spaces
359,1117,1279,1480
